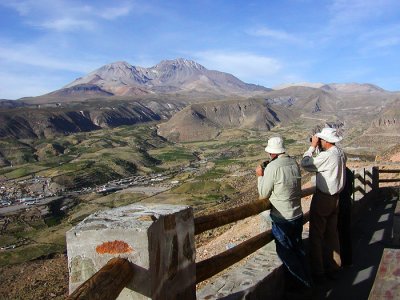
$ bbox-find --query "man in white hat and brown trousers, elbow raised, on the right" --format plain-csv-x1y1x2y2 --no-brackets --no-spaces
301,127,346,283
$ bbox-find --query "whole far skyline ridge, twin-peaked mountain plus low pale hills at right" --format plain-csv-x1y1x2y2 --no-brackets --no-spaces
10,58,395,104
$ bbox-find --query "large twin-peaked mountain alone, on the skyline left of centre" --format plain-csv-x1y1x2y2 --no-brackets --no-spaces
24,58,271,103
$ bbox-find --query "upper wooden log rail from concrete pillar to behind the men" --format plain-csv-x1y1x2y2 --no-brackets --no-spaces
194,187,315,234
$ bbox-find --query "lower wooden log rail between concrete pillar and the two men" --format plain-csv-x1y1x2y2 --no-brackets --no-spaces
196,212,309,283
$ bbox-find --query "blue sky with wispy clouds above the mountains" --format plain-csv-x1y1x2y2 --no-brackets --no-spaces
0,0,400,99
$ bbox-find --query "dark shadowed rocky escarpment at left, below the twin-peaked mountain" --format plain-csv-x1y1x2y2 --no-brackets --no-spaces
0,101,186,139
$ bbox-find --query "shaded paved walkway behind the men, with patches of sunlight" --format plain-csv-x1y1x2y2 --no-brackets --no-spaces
314,189,399,300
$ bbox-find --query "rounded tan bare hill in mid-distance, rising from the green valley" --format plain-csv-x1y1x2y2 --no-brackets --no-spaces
158,99,295,141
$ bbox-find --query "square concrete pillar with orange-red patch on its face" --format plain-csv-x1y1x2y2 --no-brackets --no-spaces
67,204,196,299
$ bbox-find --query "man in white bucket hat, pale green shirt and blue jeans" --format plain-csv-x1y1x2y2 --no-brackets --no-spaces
256,137,312,293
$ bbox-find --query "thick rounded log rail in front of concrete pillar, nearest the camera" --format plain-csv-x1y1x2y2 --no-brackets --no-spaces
67,257,133,300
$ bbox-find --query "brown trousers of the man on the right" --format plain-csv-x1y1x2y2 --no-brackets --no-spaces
310,190,341,276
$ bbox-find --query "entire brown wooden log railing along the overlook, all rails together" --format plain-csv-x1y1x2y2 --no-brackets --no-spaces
68,168,400,299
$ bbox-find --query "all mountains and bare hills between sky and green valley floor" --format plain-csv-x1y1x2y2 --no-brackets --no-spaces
0,58,400,140
